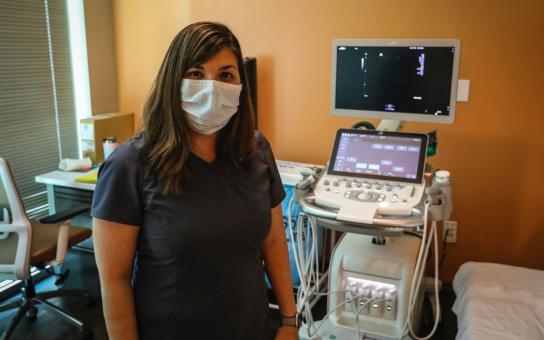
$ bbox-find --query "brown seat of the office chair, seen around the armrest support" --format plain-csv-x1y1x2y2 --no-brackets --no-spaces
30,220,92,266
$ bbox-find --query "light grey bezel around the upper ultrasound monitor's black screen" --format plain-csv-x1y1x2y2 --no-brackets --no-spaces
330,39,461,124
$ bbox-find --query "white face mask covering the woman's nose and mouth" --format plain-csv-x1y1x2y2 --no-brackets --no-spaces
181,79,242,135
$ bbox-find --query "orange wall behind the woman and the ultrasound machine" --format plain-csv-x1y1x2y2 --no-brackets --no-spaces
114,0,544,281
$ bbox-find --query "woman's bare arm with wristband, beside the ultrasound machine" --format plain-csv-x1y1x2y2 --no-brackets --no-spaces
263,204,298,335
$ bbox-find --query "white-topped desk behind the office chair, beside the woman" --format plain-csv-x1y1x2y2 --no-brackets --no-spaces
35,169,98,250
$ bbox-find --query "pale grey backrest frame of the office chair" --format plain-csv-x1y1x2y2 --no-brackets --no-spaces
0,157,32,279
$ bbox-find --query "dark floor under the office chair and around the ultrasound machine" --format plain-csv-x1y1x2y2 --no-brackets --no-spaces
0,250,457,340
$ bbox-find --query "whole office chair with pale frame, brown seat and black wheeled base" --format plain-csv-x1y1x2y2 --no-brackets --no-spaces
0,157,94,340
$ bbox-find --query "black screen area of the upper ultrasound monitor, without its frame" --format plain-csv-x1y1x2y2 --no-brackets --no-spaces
335,46,455,116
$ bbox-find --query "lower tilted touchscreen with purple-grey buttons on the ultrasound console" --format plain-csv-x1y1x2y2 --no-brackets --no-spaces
328,129,427,183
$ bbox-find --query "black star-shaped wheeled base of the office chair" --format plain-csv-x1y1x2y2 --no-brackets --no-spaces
0,279,96,340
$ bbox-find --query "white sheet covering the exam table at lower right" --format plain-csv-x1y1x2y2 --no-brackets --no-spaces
452,262,544,340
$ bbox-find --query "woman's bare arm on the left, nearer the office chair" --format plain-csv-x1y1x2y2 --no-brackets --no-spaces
93,218,140,340
